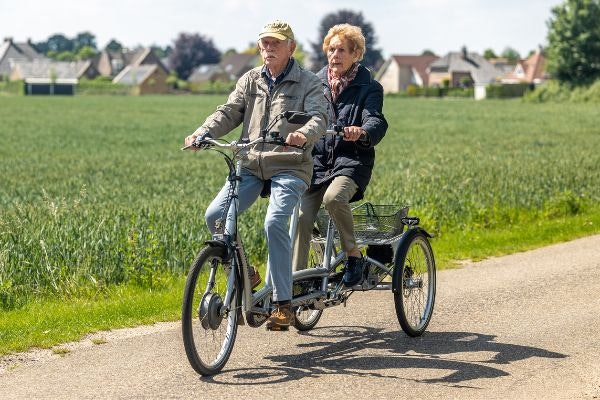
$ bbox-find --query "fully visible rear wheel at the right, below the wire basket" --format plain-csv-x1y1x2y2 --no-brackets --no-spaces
393,229,435,337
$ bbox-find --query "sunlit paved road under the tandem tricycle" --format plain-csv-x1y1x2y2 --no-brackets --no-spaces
0,235,600,400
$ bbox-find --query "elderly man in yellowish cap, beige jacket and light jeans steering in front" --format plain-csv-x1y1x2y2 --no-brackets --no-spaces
185,21,327,331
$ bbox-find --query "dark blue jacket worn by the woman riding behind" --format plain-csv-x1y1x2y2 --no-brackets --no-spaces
311,65,388,202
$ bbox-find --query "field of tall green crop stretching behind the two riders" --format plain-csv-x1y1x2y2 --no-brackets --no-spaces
0,96,600,310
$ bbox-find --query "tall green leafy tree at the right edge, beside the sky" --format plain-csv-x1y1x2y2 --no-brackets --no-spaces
547,0,600,86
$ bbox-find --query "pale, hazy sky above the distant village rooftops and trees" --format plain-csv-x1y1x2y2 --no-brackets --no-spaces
0,0,562,57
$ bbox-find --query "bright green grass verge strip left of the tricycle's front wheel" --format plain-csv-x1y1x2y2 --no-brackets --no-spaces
0,277,184,355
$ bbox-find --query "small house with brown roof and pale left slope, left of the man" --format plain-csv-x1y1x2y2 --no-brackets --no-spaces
112,64,171,95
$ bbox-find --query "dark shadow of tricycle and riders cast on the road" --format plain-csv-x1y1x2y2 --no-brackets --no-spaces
205,326,567,386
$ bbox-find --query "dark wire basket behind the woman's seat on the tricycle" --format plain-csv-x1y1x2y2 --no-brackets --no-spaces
316,203,408,244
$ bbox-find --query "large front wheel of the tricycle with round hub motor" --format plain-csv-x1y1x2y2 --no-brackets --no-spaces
181,247,241,376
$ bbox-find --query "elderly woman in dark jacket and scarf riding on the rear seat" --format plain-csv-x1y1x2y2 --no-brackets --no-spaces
293,24,388,286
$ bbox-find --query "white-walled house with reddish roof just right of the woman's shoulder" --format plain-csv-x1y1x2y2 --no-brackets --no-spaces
375,55,439,93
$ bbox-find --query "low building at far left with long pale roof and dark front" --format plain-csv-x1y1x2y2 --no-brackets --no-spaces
10,60,98,95
